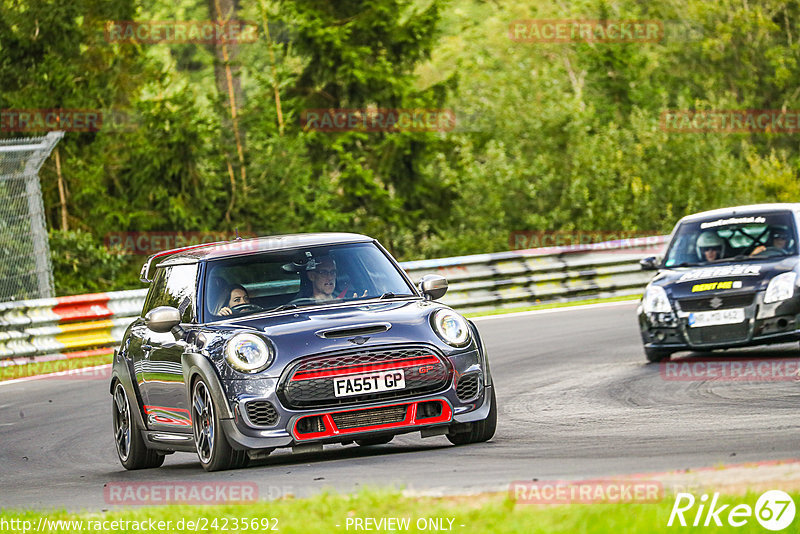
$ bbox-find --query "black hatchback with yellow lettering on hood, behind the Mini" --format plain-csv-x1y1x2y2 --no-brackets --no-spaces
638,204,800,362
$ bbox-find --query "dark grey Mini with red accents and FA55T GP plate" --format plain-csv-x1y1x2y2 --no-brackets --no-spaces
110,234,497,471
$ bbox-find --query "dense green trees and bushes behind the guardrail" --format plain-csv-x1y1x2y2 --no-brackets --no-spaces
0,0,800,293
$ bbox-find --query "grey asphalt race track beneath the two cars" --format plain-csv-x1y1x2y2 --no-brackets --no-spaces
0,303,800,510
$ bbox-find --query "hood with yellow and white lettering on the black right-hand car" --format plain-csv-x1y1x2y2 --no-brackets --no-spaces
651,256,798,298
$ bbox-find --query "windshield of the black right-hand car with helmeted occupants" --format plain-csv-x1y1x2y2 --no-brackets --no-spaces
664,212,797,267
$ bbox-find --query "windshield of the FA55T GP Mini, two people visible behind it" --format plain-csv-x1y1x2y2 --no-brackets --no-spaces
203,243,415,321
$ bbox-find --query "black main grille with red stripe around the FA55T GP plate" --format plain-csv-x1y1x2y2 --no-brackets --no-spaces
279,346,450,408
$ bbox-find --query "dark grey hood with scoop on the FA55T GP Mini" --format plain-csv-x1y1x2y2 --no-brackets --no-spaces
199,300,460,374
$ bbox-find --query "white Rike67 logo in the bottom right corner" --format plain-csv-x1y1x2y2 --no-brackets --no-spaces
667,490,795,531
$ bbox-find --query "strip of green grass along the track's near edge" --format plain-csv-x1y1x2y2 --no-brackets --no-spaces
0,490,788,534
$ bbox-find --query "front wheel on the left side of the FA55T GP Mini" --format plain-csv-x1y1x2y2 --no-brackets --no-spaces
191,378,248,471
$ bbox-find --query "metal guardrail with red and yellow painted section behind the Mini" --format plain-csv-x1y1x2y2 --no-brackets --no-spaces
0,236,667,366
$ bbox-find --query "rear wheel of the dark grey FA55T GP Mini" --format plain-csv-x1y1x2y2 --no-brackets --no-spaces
111,382,164,471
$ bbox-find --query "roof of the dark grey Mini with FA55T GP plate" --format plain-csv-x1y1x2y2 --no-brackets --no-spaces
148,232,374,265
